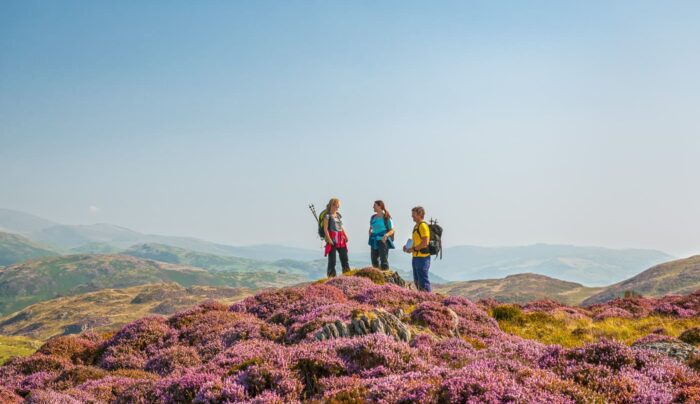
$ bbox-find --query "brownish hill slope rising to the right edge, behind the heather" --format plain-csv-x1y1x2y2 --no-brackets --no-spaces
583,255,700,305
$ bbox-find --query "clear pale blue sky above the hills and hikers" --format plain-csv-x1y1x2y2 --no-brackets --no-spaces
0,0,700,256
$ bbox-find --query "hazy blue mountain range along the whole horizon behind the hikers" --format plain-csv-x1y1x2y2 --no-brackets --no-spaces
0,209,675,286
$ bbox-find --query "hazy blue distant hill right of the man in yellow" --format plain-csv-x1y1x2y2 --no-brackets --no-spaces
398,244,673,286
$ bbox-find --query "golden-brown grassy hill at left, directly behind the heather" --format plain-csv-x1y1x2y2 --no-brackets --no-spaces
0,283,253,340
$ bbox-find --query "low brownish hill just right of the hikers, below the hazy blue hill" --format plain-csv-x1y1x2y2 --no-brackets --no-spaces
435,273,602,305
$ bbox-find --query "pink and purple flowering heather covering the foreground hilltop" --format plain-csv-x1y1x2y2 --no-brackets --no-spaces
0,269,700,404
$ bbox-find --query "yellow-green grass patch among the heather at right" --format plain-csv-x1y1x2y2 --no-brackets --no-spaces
491,306,700,347
